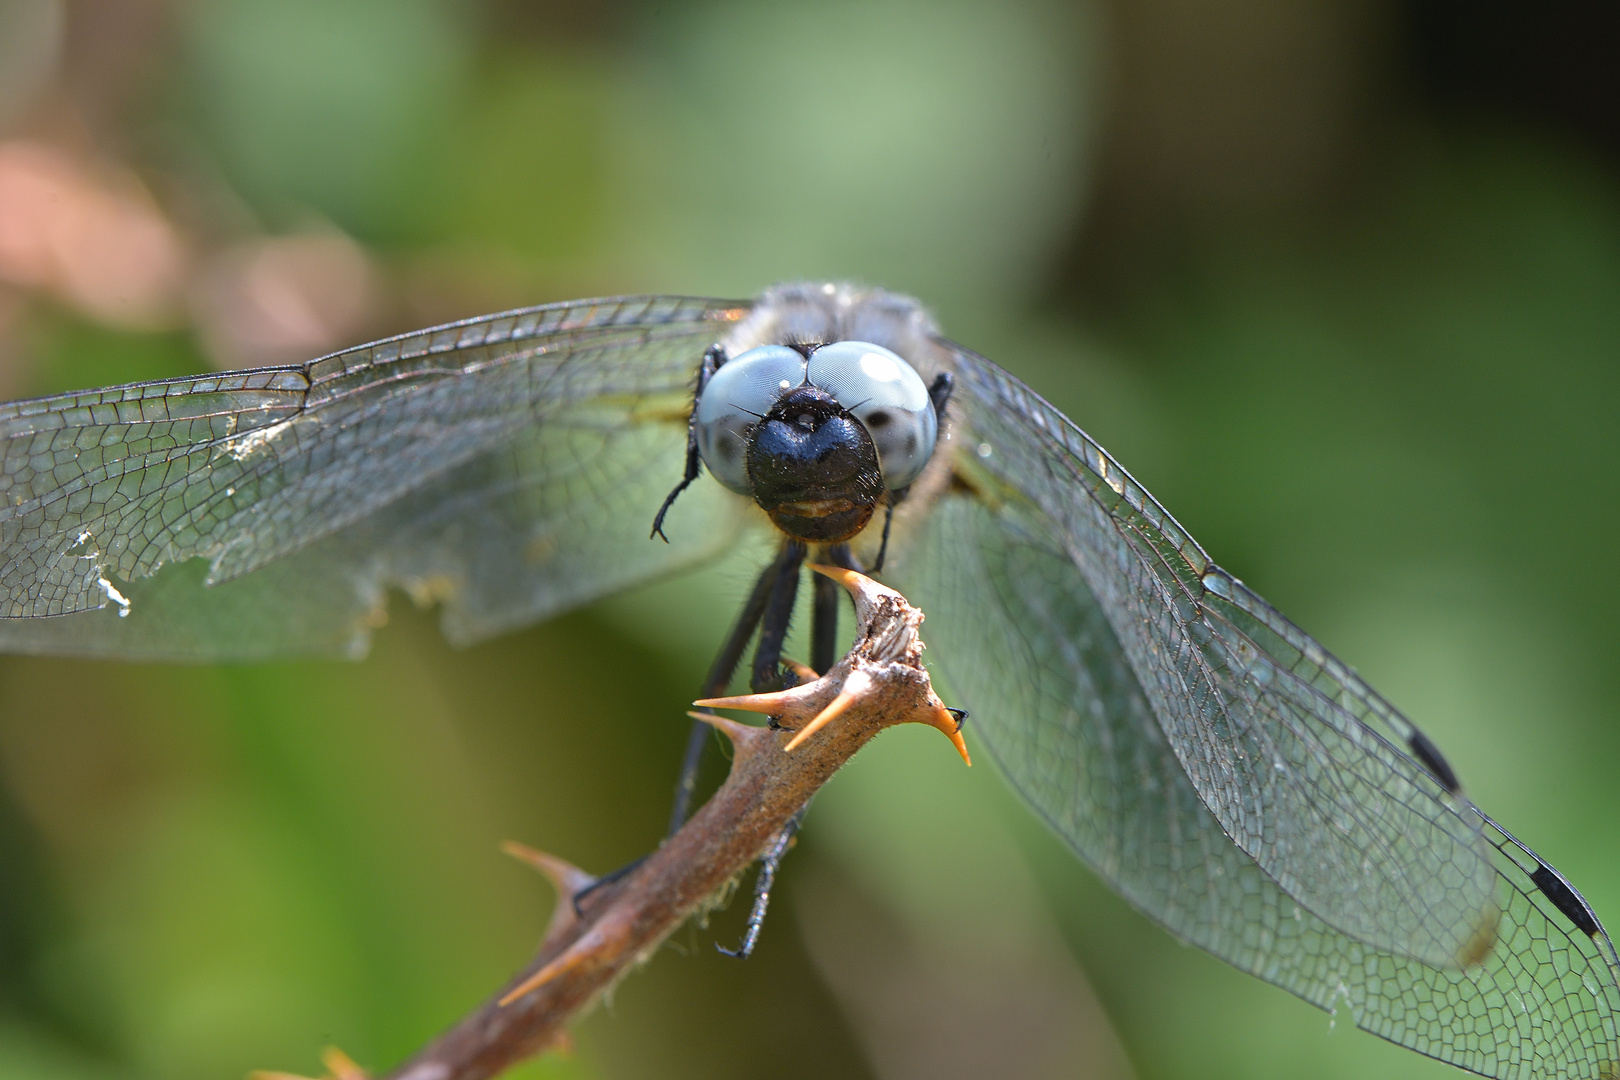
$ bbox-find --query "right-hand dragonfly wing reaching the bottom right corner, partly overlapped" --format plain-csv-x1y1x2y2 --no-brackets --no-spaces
897,492,1620,1080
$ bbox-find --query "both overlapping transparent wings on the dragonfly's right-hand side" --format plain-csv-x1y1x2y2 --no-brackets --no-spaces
896,351,1620,1077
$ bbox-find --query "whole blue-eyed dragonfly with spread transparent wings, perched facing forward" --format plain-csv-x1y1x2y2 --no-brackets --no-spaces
0,283,1620,1080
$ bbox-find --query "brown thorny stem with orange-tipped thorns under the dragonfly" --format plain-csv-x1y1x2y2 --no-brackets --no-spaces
261,567,967,1080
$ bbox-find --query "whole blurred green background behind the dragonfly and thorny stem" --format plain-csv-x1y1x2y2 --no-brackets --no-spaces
0,0,1620,1080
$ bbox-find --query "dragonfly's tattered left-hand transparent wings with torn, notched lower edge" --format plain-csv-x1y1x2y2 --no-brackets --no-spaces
0,296,747,659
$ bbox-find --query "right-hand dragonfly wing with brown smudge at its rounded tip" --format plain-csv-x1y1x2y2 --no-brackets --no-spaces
957,341,1495,967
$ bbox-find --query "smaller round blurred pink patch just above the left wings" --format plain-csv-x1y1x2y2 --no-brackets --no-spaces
198,233,379,368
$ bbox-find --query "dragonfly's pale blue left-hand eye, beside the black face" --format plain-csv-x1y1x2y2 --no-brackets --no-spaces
697,345,805,495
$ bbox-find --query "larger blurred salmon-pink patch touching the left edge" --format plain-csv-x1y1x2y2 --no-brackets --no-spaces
0,141,185,329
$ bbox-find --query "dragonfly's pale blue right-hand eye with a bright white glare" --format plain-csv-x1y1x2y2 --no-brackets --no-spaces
808,342,938,491
